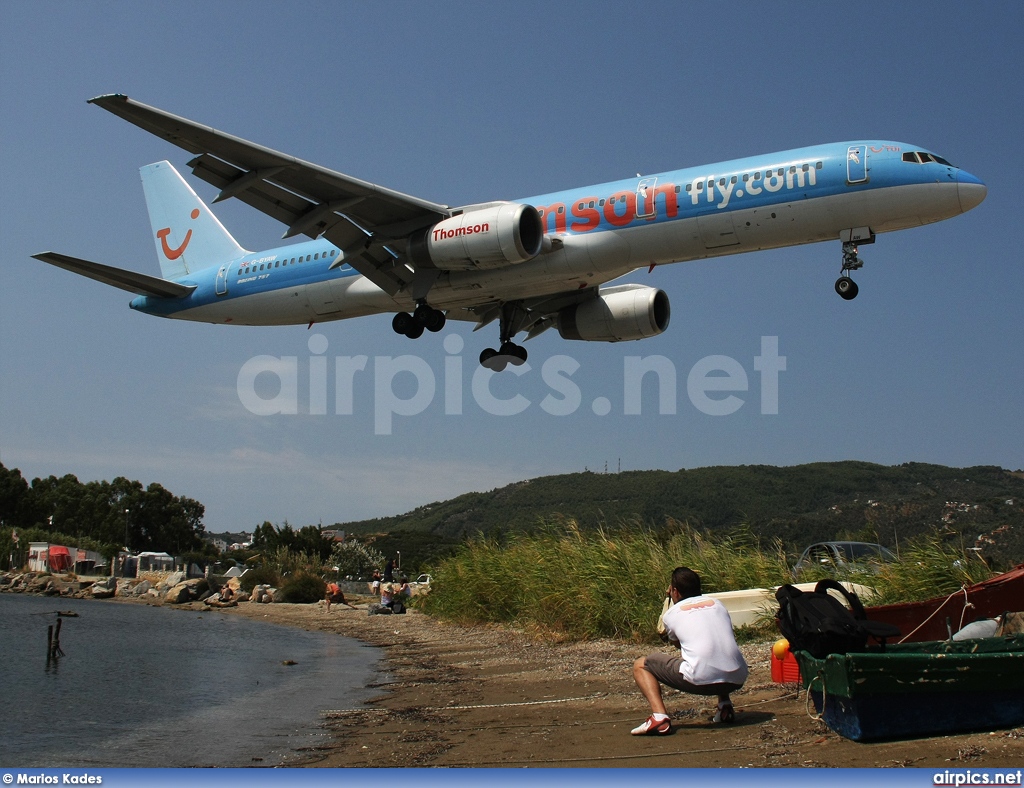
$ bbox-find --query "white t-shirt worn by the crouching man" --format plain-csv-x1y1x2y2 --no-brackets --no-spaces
664,597,748,685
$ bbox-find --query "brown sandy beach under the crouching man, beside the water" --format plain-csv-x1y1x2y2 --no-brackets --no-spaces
196,604,1024,769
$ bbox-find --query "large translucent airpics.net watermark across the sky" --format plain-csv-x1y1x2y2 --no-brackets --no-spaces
237,334,785,435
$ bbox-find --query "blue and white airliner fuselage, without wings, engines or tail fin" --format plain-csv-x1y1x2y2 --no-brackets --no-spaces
131,141,985,325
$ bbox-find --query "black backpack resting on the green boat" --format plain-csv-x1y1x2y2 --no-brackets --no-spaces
775,579,900,659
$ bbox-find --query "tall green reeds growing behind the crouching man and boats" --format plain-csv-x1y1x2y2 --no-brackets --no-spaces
418,520,990,642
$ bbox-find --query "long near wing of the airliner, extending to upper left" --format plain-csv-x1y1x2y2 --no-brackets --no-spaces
87,94,452,295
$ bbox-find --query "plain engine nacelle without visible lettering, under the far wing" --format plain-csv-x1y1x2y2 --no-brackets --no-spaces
558,284,672,342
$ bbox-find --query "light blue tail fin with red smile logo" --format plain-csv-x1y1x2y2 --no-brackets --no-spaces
139,162,246,279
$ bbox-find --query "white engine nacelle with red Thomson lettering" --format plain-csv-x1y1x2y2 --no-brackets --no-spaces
409,203,544,271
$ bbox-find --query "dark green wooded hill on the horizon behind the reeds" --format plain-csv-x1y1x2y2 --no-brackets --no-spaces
336,462,1024,566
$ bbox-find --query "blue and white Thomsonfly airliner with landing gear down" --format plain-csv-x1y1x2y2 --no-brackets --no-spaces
33,94,987,371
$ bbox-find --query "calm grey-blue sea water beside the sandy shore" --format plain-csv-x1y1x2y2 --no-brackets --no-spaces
0,594,380,768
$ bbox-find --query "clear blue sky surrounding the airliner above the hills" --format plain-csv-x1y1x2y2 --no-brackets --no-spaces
0,0,1024,531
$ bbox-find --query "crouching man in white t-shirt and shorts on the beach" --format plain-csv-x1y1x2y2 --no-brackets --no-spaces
630,566,748,736
